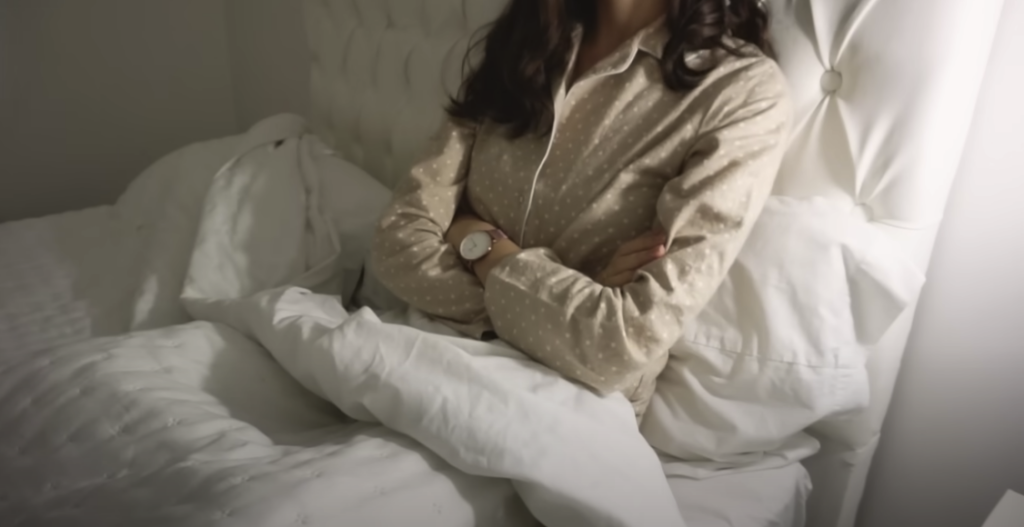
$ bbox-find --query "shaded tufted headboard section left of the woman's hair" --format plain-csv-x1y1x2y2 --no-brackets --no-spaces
304,0,504,186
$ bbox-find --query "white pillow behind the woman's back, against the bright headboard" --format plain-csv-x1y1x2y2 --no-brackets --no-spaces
642,196,924,477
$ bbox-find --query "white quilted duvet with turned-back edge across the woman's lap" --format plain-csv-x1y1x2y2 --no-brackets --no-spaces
0,116,683,526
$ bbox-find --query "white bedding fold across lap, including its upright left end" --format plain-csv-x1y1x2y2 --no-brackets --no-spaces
176,113,683,527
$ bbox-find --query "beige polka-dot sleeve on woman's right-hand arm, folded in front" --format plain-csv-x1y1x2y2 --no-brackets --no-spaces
485,60,792,393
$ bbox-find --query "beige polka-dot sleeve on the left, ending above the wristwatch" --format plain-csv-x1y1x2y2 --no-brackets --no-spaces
372,120,490,338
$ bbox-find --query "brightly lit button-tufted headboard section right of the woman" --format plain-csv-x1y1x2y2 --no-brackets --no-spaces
769,0,1002,527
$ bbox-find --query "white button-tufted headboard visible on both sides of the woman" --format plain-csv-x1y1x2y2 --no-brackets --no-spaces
304,0,1002,527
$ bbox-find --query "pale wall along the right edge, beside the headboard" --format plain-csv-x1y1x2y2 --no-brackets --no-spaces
858,0,1024,527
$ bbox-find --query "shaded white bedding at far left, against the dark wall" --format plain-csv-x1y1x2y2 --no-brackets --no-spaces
0,125,243,353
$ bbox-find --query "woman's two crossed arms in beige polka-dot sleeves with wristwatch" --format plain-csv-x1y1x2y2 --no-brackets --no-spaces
374,69,790,393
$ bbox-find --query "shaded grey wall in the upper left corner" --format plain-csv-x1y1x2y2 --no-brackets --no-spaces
0,0,234,221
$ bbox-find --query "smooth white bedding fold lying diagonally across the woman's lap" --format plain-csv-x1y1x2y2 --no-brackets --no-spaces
192,288,683,527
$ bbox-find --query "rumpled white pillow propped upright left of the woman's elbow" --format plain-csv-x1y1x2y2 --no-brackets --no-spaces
182,134,390,316
